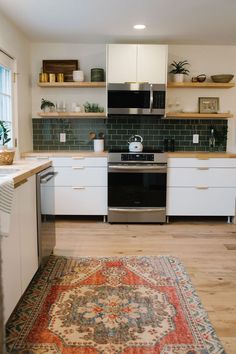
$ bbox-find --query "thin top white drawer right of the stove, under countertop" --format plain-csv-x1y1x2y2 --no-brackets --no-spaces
168,157,236,167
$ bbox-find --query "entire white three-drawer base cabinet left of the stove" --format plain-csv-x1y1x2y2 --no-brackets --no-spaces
52,157,107,215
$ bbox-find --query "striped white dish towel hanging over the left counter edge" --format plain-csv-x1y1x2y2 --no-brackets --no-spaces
0,178,14,236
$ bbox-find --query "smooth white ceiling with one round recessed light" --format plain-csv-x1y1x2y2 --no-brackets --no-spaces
0,0,236,45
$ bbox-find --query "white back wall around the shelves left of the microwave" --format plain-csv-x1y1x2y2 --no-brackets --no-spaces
31,43,106,118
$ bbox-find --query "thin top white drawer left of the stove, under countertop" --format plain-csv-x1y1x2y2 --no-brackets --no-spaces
51,156,107,167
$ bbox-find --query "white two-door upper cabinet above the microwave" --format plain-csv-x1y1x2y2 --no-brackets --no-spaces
107,44,168,84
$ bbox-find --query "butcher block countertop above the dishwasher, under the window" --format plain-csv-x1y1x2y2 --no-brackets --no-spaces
0,160,52,188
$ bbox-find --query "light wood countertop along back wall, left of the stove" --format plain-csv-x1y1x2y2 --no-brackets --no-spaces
21,150,108,158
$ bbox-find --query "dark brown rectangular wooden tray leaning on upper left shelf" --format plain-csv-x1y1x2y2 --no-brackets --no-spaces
43,59,79,81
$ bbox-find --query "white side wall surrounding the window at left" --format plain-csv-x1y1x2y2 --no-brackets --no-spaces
0,13,32,152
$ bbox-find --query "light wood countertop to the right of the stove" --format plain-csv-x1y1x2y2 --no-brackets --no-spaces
168,151,236,159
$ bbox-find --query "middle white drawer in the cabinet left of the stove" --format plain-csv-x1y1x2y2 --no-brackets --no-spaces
54,165,107,187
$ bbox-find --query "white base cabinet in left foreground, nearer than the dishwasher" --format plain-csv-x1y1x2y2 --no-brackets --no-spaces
1,176,38,322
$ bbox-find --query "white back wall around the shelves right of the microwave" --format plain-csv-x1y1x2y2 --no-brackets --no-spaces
167,45,236,152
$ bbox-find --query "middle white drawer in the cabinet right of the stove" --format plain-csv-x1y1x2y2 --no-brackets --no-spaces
167,167,236,187
